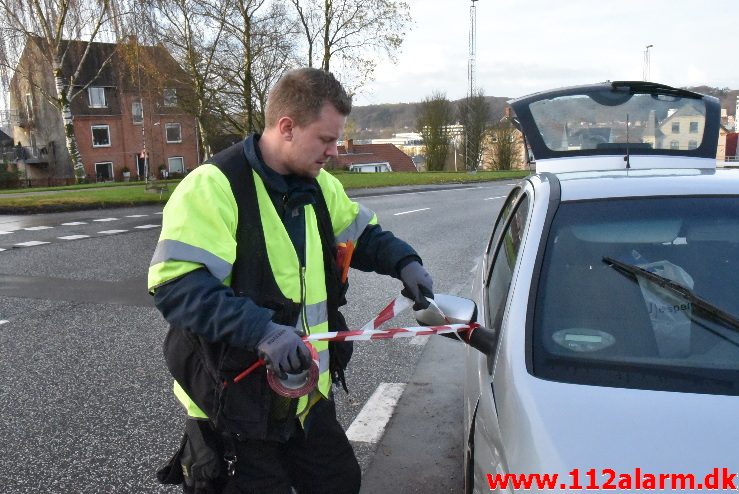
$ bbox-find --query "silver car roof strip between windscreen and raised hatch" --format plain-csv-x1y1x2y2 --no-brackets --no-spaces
534,168,739,201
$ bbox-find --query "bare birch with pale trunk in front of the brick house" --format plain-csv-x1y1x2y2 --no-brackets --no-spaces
0,0,117,180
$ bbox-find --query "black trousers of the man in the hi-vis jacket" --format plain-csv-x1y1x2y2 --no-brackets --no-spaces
184,400,361,494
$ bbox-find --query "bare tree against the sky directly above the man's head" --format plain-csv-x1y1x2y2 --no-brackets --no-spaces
290,0,411,86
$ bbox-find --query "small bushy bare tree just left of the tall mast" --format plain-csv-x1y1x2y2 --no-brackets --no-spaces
417,92,454,171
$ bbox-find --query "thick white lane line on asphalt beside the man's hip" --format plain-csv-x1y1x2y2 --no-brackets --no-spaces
346,383,405,443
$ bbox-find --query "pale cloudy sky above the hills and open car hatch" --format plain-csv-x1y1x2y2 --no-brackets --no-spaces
355,0,739,105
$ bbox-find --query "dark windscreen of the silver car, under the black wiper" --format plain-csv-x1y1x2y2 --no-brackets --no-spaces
530,197,739,395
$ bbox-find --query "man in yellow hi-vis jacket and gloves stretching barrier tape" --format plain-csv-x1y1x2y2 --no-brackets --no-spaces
149,69,433,494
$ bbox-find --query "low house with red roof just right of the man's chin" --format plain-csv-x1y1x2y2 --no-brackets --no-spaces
330,139,418,173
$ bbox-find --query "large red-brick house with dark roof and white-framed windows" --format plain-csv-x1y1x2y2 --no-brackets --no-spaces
10,39,199,181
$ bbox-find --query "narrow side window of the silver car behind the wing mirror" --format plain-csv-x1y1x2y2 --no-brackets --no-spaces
486,195,529,372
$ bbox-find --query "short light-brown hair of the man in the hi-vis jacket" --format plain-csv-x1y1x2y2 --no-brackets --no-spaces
265,67,352,127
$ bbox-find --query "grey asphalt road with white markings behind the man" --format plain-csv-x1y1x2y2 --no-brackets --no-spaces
0,183,510,494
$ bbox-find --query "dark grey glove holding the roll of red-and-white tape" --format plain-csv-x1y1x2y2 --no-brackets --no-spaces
257,321,311,379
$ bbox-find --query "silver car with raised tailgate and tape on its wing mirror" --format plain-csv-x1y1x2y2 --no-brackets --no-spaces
464,82,739,493
